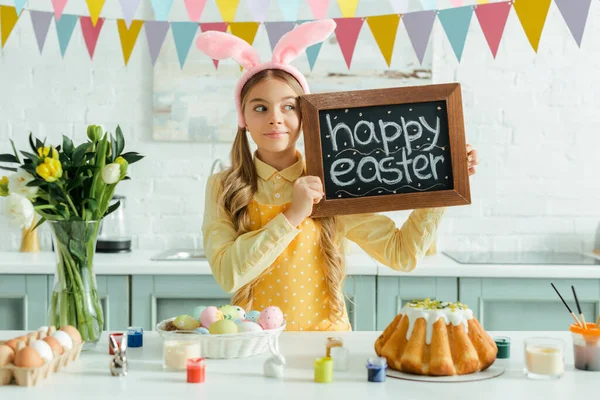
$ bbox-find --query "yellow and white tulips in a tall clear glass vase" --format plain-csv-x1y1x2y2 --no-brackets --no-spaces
0,125,143,348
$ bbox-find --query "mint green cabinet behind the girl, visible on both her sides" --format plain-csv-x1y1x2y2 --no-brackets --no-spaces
131,275,376,330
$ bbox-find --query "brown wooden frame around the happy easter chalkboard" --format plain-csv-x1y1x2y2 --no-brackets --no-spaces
300,83,471,217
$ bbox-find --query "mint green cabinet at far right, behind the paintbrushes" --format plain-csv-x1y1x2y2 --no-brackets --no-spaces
459,278,600,331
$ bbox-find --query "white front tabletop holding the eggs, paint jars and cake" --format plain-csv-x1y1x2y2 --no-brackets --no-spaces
0,331,600,400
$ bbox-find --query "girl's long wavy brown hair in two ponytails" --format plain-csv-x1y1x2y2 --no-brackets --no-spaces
219,69,345,322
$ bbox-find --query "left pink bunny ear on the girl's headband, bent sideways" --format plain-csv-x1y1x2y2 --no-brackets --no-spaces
196,31,260,69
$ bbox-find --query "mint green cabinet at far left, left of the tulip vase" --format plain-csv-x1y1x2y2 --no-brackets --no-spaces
0,275,48,330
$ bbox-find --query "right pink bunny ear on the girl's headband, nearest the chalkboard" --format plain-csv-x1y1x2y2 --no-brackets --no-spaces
272,19,336,64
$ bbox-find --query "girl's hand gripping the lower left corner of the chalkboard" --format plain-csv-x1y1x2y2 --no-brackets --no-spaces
283,176,325,226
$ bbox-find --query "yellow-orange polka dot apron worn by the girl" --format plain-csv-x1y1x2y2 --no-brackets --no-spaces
248,201,351,331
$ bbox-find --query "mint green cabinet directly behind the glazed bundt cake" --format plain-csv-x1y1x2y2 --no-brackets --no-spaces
376,276,458,330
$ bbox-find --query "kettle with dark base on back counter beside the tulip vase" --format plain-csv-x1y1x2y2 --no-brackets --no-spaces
96,194,131,253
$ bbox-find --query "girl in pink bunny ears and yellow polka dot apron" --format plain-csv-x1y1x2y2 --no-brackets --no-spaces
197,20,478,331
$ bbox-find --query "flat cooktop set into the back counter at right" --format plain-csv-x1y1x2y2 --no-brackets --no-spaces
443,251,600,265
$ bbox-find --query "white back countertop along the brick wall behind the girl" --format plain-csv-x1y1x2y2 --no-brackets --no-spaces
0,250,600,279
